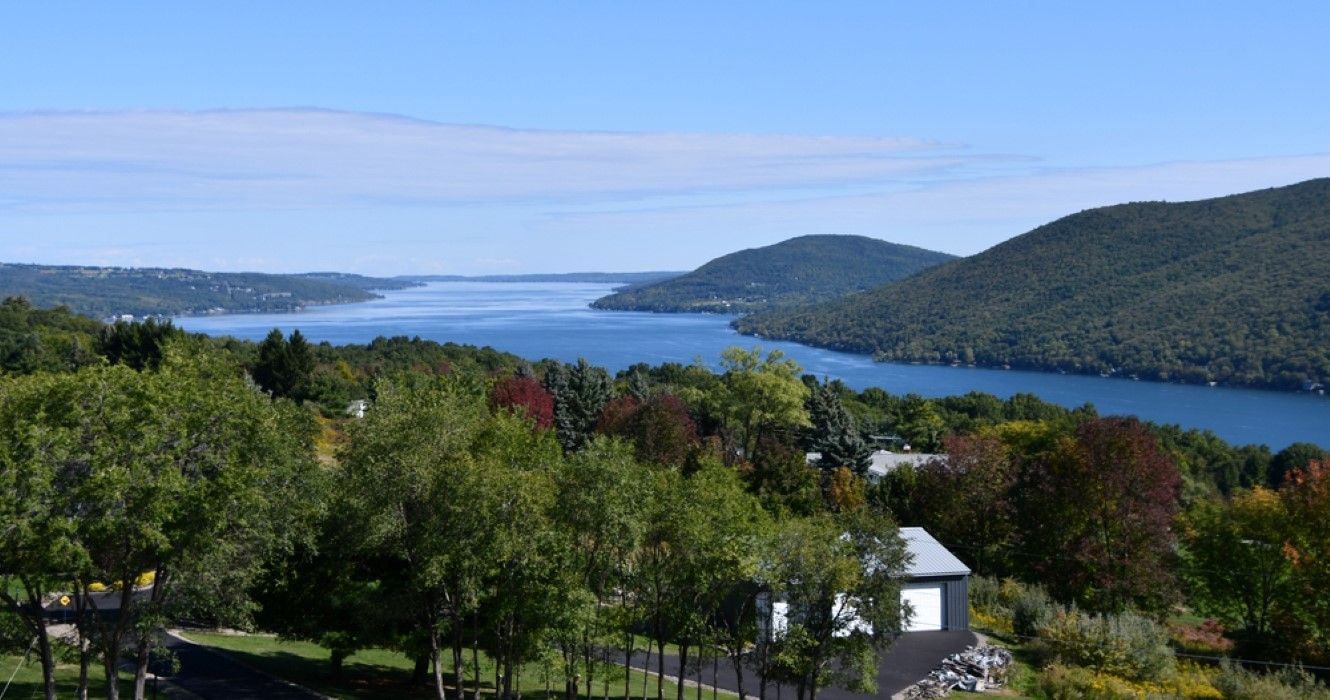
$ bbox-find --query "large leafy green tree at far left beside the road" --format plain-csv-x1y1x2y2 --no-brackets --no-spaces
0,343,315,697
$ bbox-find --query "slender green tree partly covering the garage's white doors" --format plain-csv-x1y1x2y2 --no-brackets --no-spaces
765,508,906,700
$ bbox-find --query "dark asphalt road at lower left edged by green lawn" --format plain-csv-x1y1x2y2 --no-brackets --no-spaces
165,633,323,700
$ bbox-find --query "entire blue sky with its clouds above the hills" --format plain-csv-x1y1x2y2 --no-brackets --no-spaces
0,0,1330,274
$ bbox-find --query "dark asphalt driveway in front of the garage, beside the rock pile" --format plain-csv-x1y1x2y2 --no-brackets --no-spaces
620,631,978,700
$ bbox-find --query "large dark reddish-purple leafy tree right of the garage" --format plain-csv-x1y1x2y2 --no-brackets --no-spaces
1015,417,1180,612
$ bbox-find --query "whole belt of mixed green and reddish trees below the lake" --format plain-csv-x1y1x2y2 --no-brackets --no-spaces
0,302,1330,700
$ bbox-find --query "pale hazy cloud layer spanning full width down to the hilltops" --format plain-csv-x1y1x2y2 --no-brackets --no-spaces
0,110,1330,273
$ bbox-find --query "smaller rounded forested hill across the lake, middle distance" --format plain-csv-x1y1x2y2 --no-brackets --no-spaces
592,236,952,313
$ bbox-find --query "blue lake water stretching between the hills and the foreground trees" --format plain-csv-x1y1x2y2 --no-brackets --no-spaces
176,282,1330,450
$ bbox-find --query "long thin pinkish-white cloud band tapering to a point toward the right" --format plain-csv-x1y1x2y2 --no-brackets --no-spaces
0,110,1004,212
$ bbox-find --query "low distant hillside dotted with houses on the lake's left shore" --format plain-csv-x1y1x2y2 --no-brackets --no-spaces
0,263,412,318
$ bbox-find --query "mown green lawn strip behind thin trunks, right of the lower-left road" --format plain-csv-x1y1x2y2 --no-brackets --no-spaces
184,631,693,700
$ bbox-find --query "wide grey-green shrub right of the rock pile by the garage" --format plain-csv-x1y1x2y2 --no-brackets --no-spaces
1035,610,1176,680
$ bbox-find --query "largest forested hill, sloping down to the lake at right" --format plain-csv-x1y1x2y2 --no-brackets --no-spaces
735,178,1330,389
